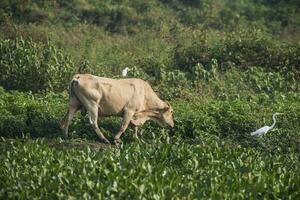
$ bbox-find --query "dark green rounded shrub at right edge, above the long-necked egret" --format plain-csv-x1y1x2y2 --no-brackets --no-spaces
214,30,300,71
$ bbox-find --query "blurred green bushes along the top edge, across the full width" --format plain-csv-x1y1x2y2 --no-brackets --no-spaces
0,0,300,34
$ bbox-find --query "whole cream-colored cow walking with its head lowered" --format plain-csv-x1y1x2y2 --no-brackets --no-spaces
61,74,174,143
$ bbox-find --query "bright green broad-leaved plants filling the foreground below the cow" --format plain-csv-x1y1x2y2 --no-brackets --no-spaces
0,135,300,199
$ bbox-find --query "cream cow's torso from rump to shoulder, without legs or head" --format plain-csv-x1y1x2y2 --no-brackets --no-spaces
74,74,148,116
